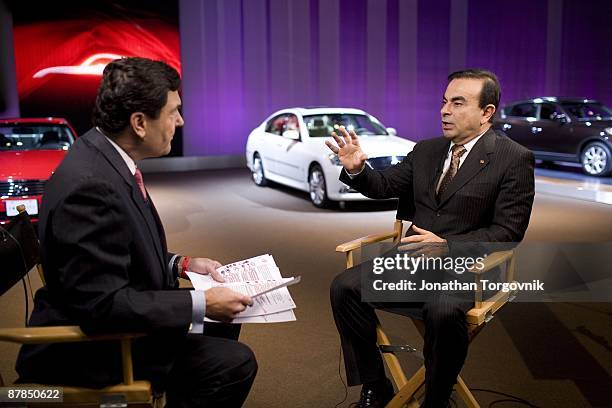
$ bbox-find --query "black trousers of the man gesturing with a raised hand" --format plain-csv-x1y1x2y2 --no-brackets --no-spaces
330,265,472,408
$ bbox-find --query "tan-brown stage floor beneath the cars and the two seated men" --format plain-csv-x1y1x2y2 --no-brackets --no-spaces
0,169,612,408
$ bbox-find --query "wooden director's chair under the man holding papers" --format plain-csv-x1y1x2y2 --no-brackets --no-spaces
0,205,158,408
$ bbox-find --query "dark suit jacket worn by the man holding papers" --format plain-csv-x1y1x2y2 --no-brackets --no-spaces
17,129,191,386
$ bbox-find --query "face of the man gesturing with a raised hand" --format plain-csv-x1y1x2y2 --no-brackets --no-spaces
440,78,487,144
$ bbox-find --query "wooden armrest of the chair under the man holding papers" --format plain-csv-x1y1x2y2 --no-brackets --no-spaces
0,326,145,344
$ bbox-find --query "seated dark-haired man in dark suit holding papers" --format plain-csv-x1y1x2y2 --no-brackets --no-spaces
17,58,257,407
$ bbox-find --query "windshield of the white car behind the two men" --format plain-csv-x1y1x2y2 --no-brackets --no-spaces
304,113,388,137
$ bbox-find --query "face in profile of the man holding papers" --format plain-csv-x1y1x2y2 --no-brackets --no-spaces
144,91,185,157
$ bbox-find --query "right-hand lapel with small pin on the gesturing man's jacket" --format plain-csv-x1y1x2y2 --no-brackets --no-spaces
439,129,495,206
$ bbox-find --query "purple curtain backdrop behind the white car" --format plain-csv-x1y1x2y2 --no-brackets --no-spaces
179,0,612,156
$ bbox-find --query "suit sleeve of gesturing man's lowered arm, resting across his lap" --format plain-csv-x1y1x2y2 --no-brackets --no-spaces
444,150,535,244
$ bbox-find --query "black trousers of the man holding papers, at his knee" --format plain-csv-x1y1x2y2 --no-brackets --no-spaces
160,323,257,408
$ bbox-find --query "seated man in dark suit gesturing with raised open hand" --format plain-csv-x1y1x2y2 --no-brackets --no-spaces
326,70,534,408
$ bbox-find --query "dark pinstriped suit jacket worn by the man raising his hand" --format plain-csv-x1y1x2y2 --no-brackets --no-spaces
340,129,534,243
